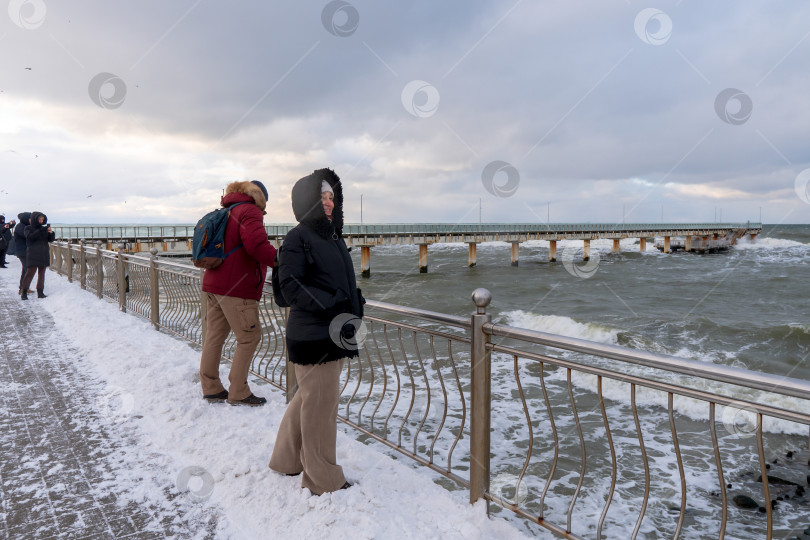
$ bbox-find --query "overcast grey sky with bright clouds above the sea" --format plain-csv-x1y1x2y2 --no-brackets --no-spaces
0,0,810,223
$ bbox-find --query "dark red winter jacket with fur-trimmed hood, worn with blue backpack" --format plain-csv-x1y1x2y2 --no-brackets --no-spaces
202,182,276,300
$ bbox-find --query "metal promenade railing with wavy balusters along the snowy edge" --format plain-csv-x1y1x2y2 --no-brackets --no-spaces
51,242,810,539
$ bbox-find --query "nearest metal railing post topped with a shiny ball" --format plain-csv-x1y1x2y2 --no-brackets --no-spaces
470,289,492,504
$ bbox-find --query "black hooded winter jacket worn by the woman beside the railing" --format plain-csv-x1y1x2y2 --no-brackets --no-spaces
278,169,365,364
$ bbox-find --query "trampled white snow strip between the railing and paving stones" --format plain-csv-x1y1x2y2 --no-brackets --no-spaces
7,266,536,539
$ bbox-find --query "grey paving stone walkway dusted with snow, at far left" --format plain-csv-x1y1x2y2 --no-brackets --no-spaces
0,265,217,540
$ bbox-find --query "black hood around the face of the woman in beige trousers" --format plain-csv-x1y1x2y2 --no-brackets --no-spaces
292,169,343,238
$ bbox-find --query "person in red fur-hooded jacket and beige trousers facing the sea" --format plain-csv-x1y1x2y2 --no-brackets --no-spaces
200,180,276,407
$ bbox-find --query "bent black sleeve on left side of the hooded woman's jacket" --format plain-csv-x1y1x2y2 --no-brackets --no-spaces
278,229,348,312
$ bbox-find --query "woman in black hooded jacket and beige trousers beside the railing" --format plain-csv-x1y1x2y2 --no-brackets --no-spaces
270,169,364,495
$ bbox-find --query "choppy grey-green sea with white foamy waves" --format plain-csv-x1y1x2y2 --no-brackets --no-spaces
55,225,810,539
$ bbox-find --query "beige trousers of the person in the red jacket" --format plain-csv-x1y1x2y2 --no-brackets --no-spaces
200,293,262,400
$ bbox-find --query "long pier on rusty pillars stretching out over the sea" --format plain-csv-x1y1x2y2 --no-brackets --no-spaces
54,222,762,276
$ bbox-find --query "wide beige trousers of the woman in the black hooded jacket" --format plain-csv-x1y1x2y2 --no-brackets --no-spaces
270,360,346,495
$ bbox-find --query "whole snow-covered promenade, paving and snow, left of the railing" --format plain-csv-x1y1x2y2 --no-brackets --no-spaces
0,257,524,539
